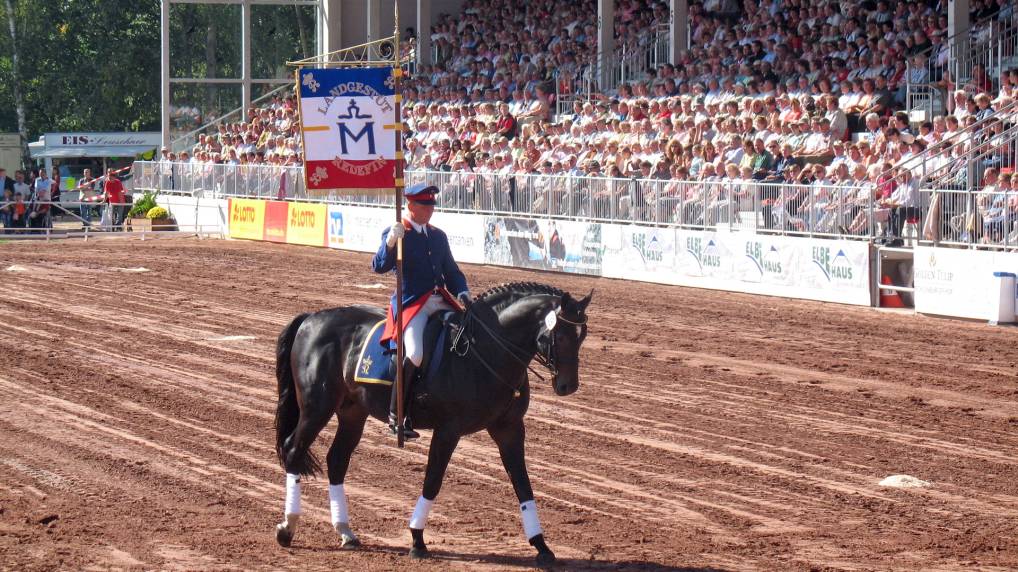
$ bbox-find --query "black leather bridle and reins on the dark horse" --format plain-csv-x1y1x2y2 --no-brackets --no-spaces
450,305,587,397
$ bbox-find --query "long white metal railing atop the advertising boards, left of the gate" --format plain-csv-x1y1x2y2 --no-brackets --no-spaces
134,161,882,239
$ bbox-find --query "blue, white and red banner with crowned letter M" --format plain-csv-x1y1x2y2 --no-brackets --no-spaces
297,67,399,194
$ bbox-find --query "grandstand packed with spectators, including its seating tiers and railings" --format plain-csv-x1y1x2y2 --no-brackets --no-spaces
141,0,1018,252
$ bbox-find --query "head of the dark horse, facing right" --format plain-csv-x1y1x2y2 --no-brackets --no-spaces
538,290,593,395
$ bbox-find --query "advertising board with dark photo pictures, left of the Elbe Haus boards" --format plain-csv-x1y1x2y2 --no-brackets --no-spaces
485,217,603,275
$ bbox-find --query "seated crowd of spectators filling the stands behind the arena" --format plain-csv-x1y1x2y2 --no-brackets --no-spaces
156,0,1018,242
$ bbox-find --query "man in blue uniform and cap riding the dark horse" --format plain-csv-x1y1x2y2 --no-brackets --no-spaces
372,183,470,439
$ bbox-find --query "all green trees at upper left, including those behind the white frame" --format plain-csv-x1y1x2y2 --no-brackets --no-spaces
0,0,315,160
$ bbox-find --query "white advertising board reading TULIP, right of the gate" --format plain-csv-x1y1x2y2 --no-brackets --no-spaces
913,246,1018,320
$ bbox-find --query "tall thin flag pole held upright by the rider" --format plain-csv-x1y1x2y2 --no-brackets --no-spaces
392,1,406,449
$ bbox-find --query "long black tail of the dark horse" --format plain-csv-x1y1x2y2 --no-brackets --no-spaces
276,313,322,475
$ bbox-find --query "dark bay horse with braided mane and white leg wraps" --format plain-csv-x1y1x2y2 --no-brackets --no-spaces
276,283,593,565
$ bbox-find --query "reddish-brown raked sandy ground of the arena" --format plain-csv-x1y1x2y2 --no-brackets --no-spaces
0,234,1018,570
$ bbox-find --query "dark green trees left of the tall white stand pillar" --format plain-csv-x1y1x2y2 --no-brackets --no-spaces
0,0,159,138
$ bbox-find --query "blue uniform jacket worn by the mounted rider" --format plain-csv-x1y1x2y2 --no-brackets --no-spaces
372,224,467,306
